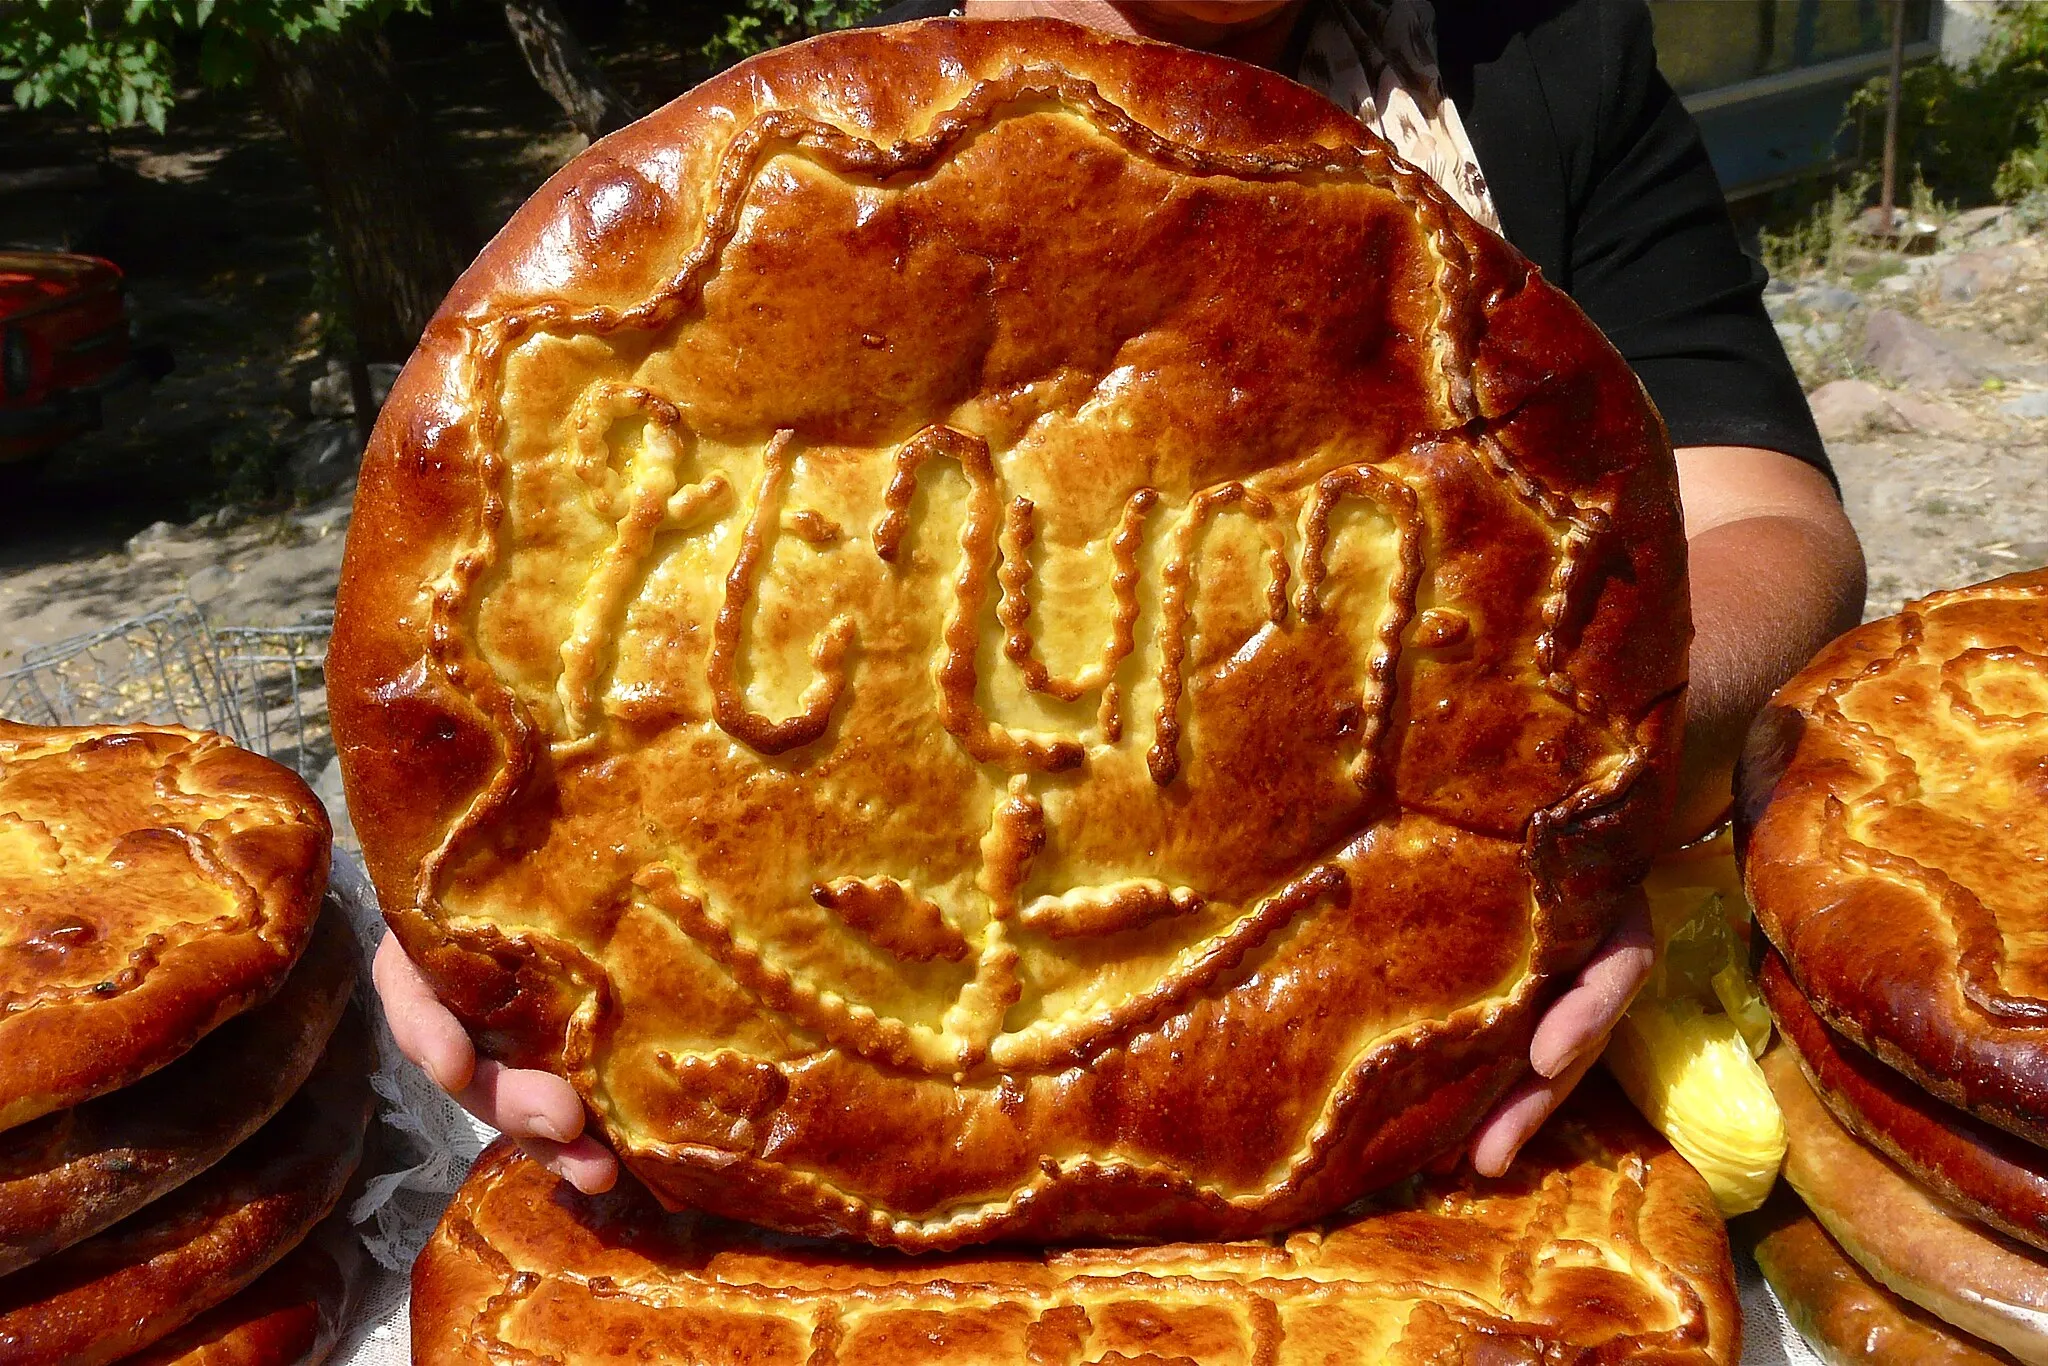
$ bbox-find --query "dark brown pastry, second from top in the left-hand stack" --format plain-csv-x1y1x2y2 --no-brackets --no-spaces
0,905,356,1276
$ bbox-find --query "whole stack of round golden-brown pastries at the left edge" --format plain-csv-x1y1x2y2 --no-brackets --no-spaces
0,721,371,1366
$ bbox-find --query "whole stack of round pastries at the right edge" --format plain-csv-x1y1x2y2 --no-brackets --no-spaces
1741,571,2048,1362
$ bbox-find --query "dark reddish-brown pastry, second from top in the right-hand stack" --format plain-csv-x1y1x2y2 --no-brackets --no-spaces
1757,950,2048,1251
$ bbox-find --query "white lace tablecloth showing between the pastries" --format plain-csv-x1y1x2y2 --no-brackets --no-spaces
330,846,1823,1366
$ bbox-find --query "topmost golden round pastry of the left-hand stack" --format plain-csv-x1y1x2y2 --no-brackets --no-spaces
0,721,330,1128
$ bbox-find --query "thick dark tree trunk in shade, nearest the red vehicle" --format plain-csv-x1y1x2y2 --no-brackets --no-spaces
256,25,481,360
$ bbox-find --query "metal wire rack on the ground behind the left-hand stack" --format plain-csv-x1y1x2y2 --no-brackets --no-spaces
0,598,334,780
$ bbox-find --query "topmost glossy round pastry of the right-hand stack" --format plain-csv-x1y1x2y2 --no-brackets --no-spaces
1739,569,2048,1145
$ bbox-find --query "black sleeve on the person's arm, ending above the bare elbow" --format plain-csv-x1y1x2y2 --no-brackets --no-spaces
1534,0,1835,479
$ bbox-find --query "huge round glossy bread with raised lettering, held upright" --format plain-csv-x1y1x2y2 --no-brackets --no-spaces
328,20,1688,1247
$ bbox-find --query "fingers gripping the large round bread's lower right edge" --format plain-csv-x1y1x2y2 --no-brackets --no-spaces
1470,891,1655,1176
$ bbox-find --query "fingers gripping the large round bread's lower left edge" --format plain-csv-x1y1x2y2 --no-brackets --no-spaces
371,930,618,1196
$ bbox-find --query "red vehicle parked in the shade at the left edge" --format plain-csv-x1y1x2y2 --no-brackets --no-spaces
0,252,170,461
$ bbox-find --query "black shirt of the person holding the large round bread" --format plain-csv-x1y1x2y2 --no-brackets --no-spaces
874,0,1833,479
